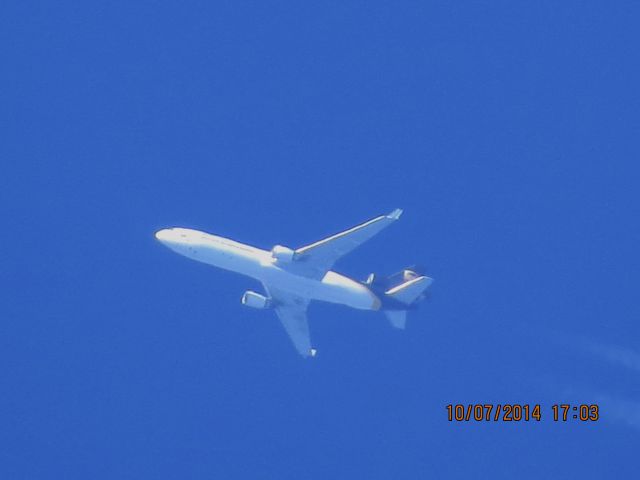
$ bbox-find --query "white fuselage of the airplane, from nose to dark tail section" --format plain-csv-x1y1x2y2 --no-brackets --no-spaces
156,228,381,310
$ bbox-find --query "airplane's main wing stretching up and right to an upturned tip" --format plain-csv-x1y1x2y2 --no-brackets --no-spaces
292,208,402,279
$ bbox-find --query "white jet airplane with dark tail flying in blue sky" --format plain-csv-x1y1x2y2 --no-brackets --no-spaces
155,208,433,358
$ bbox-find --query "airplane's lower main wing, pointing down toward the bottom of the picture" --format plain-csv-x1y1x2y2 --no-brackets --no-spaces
264,285,316,357
